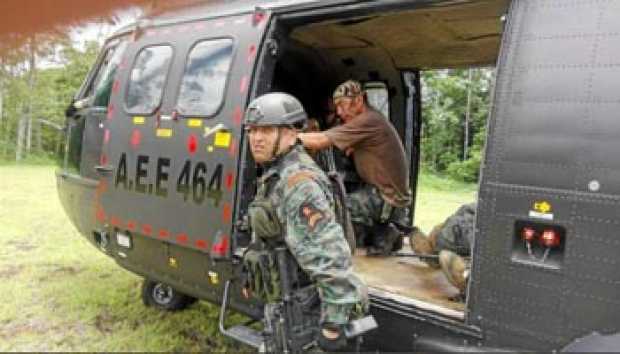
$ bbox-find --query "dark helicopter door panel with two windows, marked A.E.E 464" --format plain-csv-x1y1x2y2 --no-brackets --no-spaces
95,9,267,266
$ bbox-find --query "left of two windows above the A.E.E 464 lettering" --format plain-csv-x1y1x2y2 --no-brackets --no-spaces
126,45,172,114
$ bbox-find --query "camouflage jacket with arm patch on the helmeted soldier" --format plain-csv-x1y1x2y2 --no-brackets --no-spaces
253,145,368,324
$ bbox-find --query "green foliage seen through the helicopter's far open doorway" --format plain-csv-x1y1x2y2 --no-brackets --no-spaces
421,68,493,182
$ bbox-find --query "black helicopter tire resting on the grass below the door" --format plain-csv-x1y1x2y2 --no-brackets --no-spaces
142,279,197,311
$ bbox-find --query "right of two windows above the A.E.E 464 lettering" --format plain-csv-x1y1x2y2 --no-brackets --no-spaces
177,39,233,116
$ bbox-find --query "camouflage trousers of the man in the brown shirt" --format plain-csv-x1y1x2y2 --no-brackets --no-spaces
347,185,408,227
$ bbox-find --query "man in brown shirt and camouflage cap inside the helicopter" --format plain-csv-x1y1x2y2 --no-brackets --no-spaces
298,80,411,254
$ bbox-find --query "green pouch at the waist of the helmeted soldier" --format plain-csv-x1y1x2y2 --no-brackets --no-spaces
243,249,282,303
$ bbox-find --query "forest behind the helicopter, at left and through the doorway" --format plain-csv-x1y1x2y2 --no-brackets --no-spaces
0,32,494,182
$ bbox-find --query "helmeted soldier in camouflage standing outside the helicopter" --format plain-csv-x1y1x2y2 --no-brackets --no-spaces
245,93,367,351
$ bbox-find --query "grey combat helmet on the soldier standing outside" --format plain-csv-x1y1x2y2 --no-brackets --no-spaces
244,92,308,129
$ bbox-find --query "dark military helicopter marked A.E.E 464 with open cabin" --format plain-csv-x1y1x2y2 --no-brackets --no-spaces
57,0,620,352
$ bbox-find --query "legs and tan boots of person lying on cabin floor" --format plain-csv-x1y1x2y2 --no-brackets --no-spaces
410,203,476,296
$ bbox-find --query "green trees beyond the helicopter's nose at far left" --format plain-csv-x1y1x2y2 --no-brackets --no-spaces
0,36,99,161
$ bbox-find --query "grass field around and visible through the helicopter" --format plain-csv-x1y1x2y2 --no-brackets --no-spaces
0,165,475,352
